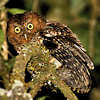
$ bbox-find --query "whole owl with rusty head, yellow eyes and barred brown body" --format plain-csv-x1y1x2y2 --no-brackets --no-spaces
7,12,94,93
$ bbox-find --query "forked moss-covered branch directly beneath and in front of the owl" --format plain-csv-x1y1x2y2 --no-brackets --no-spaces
10,43,78,100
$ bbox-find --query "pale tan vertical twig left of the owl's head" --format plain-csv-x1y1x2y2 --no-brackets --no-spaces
0,0,8,60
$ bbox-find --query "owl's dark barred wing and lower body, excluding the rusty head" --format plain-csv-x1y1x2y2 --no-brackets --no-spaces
41,23,94,93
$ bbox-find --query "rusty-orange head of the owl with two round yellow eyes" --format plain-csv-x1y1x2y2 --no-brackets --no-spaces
7,12,46,47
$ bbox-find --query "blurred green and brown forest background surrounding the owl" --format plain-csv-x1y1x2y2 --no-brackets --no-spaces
0,0,100,100
